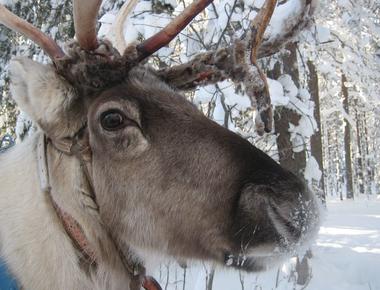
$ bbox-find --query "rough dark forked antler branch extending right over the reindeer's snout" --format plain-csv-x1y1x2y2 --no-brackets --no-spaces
156,0,277,134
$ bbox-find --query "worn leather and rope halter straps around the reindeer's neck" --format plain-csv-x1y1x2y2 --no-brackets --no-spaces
37,133,162,290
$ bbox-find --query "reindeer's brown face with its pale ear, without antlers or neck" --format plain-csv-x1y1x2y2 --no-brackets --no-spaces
11,59,318,271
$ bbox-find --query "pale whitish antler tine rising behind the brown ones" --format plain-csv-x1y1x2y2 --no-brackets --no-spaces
108,0,139,53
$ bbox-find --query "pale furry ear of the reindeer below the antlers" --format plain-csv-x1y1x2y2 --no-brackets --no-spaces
9,58,83,138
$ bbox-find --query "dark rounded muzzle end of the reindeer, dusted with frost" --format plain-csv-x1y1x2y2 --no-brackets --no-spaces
238,179,319,250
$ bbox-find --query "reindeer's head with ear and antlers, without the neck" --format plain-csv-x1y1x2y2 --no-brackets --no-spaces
0,1,318,271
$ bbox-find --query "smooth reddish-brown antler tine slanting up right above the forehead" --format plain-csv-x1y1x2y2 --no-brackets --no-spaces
137,0,213,61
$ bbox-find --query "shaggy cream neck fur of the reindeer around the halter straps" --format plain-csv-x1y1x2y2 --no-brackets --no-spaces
0,132,135,290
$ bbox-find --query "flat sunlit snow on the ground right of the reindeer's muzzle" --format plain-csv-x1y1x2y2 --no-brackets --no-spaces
307,199,380,290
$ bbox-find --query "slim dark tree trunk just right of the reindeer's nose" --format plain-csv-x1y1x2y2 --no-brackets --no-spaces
307,60,326,203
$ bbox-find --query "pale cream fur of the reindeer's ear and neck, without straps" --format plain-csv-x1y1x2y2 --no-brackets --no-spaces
0,59,134,290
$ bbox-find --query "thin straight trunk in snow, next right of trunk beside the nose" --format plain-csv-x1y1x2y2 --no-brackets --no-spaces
342,73,354,199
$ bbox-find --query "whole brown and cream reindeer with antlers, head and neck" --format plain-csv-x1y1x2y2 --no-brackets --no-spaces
0,0,319,290
